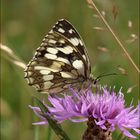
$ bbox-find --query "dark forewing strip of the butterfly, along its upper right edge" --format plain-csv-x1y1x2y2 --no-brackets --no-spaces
52,19,91,77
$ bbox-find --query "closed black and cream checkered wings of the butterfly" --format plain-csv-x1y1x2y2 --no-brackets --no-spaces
25,19,91,94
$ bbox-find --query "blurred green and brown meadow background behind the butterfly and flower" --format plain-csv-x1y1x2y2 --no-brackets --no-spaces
1,0,139,140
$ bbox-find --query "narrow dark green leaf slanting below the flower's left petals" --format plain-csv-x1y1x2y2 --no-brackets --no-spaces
34,97,70,140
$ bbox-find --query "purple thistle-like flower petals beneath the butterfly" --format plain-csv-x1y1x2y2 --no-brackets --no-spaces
30,87,140,138
